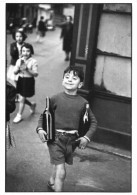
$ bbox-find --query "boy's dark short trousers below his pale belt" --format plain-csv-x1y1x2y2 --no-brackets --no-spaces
47,132,78,165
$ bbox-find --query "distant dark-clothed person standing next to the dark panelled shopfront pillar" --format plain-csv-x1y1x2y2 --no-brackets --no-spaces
60,16,73,61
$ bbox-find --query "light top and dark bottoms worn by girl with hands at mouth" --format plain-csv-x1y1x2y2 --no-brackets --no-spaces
15,57,38,97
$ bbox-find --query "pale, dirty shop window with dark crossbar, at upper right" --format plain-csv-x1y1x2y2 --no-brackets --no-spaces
94,4,132,98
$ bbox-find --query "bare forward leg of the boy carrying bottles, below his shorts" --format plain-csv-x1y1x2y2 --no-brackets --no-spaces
55,163,66,192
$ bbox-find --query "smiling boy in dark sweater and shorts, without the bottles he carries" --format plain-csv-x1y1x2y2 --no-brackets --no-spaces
37,66,97,192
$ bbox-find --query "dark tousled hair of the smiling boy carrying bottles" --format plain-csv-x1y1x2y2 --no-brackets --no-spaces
63,66,84,82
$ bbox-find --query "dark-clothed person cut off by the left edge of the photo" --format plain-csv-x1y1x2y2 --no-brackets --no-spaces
6,81,16,150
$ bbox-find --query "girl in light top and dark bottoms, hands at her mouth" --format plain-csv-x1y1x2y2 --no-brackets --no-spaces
13,43,38,123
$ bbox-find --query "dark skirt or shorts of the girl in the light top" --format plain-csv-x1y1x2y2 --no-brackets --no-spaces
17,77,35,97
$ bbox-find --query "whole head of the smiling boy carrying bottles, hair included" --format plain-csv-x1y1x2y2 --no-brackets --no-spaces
62,66,84,93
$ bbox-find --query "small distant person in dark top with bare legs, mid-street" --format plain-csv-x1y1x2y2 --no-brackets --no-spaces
36,16,46,42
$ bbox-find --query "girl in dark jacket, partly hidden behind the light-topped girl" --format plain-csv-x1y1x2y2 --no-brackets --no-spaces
7,29,27,87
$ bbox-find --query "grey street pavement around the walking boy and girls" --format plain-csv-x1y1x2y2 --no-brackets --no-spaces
5,28,131,192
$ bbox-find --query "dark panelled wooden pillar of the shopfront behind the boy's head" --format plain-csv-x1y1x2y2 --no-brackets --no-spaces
70,4,102,98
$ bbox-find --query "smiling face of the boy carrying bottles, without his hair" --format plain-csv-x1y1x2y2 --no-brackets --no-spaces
62,71,83,91
